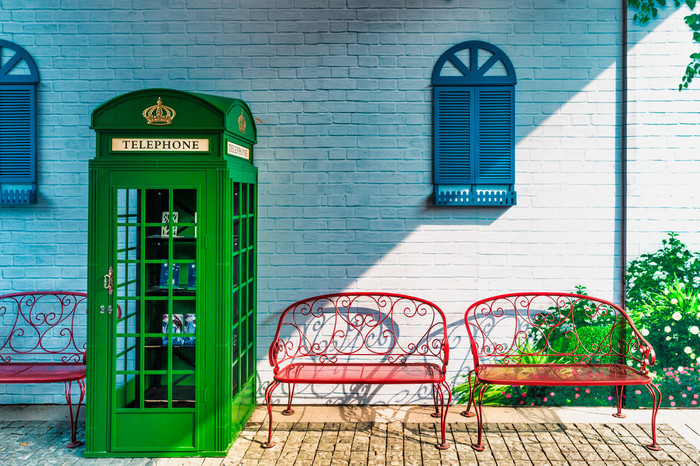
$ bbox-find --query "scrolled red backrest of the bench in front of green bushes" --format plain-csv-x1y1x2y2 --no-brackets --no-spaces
464,292,654,371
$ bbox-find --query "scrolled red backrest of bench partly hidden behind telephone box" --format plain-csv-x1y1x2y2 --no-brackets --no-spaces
0,291,87,364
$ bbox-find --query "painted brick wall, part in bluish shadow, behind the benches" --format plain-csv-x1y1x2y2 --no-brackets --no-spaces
0,0,700,403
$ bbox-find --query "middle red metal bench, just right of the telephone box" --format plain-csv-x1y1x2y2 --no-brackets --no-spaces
263,293,452,449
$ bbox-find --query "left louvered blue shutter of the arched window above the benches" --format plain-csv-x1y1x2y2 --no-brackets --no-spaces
433,87,474,184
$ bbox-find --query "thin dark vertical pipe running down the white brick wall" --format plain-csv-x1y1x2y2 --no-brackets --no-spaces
620,0,627,309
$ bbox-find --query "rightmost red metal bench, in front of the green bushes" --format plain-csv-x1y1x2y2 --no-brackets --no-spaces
462,293,661,451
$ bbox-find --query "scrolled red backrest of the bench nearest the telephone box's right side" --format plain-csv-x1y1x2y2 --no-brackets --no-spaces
269,292,449,369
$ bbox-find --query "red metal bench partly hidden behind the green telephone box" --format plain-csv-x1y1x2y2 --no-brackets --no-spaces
0,291,87,448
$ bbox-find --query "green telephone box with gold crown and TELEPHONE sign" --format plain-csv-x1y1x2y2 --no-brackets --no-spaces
85,89,257,457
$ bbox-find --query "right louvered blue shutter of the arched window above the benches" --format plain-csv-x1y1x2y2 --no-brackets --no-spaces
475,87,515,184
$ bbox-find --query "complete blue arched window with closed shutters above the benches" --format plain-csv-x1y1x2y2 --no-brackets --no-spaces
432,41,516,205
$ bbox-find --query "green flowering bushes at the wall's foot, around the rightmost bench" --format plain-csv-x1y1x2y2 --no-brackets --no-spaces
455,233,700,408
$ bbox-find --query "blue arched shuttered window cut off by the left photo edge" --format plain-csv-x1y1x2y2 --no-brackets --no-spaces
0,40,39,204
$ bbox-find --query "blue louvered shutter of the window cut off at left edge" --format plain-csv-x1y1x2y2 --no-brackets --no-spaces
0,85,35,183
